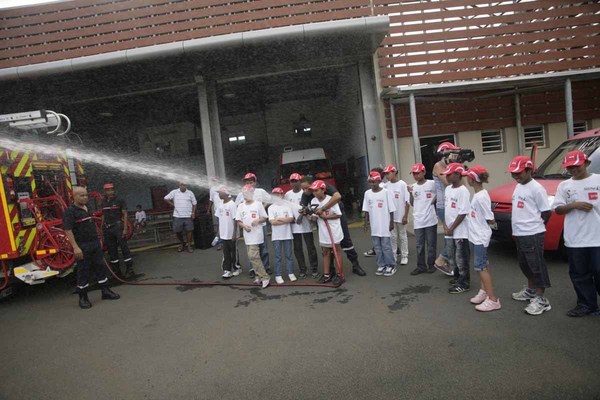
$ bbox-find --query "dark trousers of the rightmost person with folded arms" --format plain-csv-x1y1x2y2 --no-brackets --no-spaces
567,247,600,311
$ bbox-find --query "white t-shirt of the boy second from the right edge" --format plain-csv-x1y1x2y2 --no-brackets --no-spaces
511,179,550,236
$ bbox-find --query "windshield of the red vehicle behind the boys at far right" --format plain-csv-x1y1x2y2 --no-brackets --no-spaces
535,136,600,179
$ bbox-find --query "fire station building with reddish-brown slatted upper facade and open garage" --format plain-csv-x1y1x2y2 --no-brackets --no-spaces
0,0,600,208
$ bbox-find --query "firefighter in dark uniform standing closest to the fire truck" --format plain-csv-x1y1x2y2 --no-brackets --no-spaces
63,186,120,308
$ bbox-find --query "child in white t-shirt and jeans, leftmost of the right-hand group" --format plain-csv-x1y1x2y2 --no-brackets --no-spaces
362,171,396,276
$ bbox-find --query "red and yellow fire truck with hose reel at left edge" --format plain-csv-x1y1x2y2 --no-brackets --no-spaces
0,111,89,297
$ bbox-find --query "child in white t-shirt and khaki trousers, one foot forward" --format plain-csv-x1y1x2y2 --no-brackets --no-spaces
235,185,270,289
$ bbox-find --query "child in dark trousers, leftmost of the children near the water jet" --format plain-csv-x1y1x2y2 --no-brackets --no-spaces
215,186,241,279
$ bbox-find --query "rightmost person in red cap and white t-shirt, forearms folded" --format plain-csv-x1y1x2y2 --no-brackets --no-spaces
552,150,600,317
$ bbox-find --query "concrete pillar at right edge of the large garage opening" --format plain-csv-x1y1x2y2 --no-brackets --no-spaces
358,59,383,169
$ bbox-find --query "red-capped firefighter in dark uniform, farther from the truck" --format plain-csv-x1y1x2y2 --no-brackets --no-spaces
102,183,135,279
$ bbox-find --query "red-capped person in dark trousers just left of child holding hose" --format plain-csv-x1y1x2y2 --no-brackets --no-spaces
284,173,319,279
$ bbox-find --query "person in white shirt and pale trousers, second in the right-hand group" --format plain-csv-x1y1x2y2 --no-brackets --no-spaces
383,164,410,265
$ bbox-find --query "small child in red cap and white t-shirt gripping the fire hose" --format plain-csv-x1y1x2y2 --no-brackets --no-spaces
309,180,344,283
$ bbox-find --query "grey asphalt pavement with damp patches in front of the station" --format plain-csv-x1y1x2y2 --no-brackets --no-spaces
0,229,600,400
